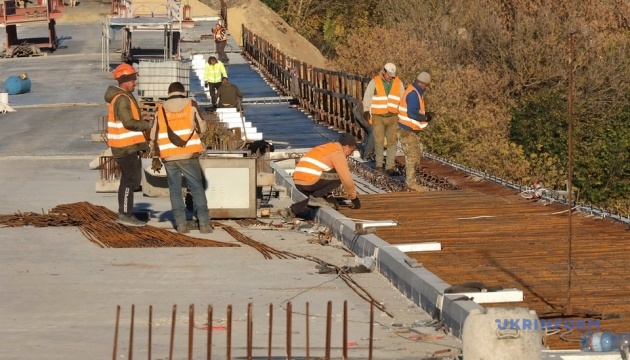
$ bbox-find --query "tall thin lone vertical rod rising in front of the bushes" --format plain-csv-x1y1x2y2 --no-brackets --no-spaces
566,31,575,315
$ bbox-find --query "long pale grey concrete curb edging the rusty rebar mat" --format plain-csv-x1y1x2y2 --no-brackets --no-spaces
271,163,484,339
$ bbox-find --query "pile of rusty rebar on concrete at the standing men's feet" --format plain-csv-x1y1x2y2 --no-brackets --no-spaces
0,202,239,248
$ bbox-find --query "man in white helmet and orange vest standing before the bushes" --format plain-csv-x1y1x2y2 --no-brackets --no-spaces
363,63,405,176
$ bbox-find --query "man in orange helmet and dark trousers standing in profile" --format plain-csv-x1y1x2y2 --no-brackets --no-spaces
105,64,150,226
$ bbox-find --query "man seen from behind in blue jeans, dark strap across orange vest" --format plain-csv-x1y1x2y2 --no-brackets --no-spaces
150,82,212,234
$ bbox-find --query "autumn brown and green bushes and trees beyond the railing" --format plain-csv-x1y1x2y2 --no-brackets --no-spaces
263,0,630,214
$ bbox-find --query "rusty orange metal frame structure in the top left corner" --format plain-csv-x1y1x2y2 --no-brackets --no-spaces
0,0,65,57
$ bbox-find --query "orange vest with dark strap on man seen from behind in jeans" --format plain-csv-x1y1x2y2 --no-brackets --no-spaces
157,101,203,159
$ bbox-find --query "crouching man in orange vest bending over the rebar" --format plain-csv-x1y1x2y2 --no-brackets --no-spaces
280,133,361,221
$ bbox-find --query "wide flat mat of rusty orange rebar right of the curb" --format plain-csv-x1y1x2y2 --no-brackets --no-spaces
340,171,630,349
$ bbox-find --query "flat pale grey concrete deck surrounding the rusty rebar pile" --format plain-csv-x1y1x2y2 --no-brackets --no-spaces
0,5,461,360
